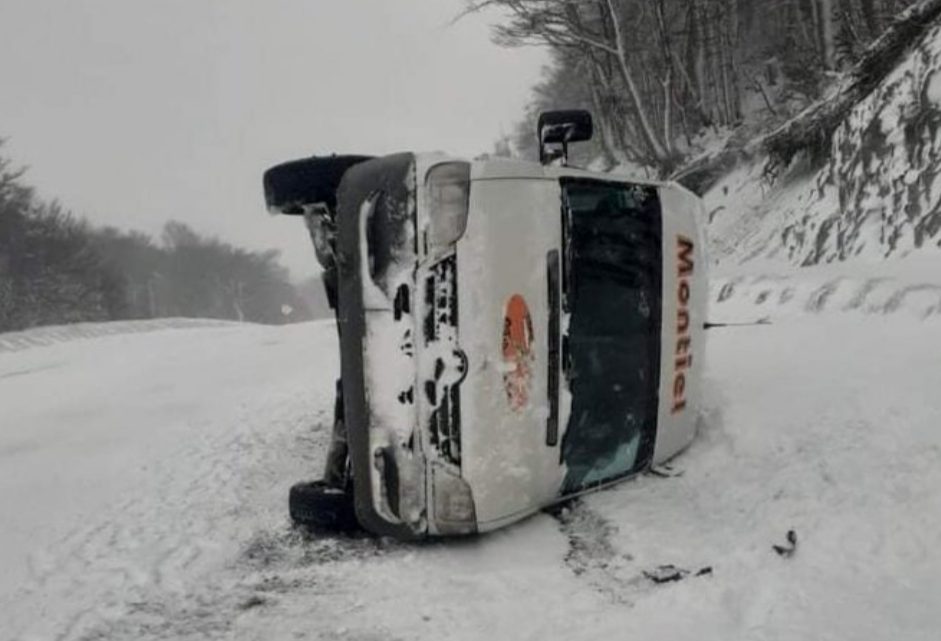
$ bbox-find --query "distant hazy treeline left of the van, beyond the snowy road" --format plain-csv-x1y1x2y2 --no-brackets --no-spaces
0,145,311,331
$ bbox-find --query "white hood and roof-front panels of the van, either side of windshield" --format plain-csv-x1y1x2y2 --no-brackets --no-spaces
448,161,706,531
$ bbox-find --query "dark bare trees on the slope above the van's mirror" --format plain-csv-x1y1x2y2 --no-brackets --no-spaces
474,0,925,173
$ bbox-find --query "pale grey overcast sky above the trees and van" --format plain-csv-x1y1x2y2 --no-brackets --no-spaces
0,0,546,278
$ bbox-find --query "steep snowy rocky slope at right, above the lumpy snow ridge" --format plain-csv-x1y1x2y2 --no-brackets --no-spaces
706,19,941,265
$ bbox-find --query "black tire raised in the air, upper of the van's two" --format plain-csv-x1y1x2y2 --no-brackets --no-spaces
263,156,371,214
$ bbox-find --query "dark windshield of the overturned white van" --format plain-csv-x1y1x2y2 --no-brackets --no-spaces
562,180,662,494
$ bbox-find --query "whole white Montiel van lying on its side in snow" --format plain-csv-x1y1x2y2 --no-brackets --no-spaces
265,112,707,539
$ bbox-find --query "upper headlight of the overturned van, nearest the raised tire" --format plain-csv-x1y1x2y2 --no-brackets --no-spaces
425,162,470,247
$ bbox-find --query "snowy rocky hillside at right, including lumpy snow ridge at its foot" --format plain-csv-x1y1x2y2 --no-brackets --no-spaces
704,13,941,321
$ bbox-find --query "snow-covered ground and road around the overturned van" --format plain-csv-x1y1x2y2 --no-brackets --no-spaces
0,302,941,641
